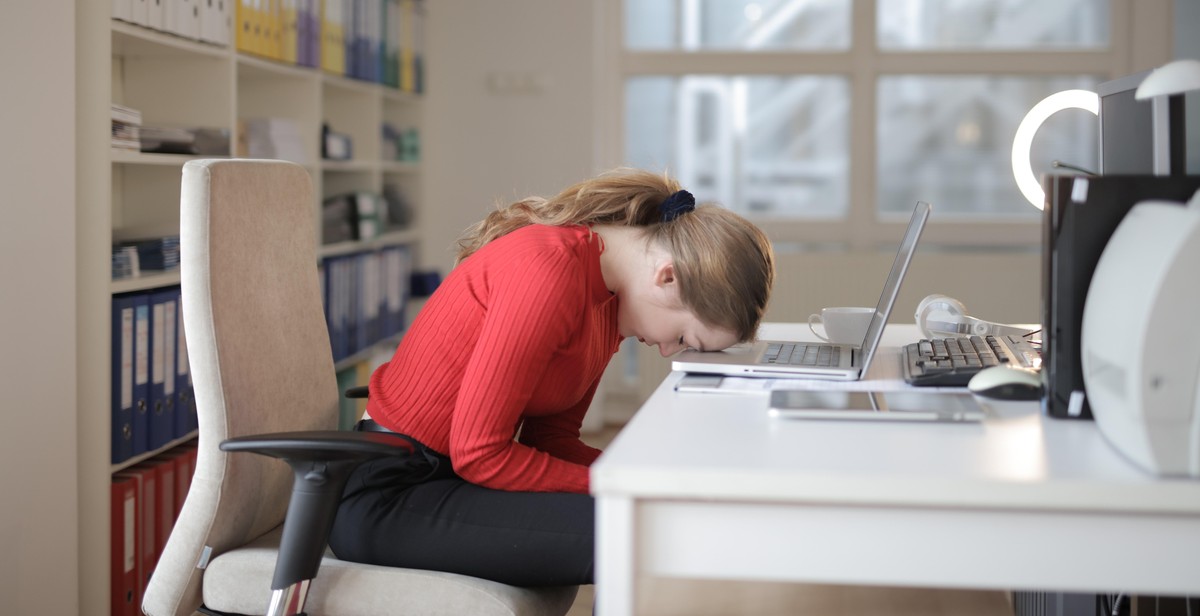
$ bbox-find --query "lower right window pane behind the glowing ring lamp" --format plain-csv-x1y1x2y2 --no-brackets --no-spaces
876,76,1099,219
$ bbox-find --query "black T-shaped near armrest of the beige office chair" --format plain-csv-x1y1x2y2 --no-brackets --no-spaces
220,430,415,591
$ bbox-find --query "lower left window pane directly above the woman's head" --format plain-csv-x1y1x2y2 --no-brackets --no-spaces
625,74,850,219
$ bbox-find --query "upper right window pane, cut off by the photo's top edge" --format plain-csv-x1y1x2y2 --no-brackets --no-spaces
875,0,1110,49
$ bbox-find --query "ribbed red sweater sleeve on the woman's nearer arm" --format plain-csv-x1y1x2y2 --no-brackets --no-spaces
449,242,588,492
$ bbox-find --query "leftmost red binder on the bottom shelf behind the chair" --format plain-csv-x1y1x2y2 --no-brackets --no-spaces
109,477,140,616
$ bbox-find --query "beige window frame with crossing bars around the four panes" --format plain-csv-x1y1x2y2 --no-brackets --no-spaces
593,0,1174,250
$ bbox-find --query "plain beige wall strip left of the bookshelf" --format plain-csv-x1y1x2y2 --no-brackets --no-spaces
0,0,79,615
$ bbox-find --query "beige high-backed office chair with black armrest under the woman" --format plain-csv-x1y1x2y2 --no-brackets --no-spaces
142,160,577,616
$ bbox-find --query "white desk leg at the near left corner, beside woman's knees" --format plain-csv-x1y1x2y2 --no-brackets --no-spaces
596,496,637,616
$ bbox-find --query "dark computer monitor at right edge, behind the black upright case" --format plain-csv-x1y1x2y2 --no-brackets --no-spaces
1096,71,1187,175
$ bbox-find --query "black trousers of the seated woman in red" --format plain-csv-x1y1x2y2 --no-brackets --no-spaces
329,421,595,586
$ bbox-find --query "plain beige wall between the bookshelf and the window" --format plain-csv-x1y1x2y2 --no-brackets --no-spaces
419,0,599,271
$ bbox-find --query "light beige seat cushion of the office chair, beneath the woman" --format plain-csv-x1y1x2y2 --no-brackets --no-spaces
204,527,578,616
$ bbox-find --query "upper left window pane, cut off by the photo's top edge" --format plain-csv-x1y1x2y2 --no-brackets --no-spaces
624,0,852,52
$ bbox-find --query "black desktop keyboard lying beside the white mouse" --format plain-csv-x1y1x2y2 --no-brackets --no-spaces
904,336,1042,387
